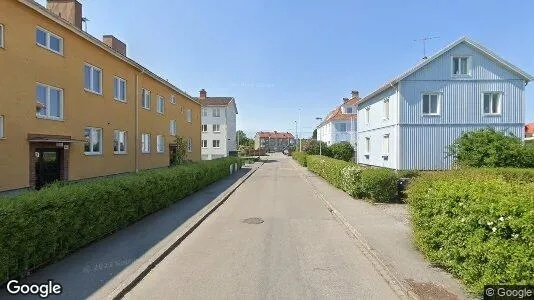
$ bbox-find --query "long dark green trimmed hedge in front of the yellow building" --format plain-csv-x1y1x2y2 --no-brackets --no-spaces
0,157,240,283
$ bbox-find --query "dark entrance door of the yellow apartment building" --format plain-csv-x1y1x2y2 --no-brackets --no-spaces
35,149,61,189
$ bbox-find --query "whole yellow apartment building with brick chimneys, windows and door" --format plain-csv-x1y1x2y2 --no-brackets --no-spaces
0,0,201,192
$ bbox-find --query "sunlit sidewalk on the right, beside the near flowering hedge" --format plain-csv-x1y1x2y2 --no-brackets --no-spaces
295,163,471,299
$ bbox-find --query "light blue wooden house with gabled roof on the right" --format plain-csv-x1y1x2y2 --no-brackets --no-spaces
357,37,534,170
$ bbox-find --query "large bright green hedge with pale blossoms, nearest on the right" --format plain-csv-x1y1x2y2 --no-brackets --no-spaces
408,169,534,292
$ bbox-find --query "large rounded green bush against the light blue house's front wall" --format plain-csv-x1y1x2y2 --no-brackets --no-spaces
448,128,534,168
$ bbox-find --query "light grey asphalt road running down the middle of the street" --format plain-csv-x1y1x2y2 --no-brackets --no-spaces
125,155,399,299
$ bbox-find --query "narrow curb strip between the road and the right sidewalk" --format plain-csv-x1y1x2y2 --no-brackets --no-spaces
292,162,419,299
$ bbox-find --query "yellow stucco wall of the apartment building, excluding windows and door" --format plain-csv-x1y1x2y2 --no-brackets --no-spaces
0,1,200,191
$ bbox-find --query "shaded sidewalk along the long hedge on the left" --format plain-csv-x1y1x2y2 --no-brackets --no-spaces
0,163,258,299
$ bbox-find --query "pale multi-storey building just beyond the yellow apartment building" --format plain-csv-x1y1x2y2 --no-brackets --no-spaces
197,89,237,160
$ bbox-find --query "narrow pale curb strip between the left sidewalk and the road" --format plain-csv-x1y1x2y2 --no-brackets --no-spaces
106,162,263,300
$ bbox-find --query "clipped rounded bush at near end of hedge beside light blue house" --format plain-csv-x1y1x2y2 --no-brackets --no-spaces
360,168,399,203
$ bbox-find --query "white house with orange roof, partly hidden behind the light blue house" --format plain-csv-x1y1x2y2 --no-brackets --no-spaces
317,91,360,148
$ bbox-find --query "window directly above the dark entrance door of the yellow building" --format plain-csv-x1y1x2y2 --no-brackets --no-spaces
36,83,63,120
